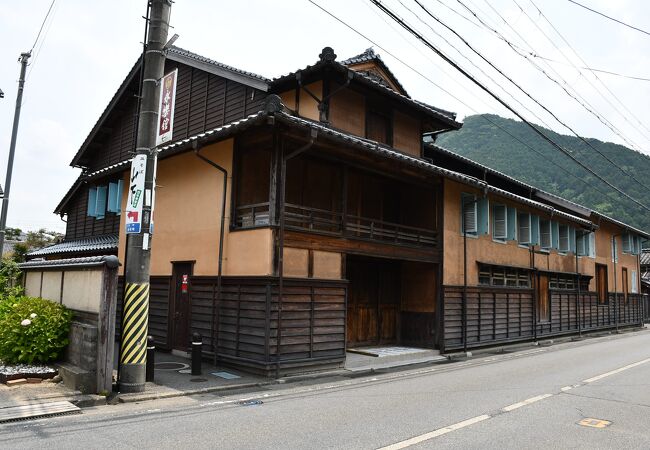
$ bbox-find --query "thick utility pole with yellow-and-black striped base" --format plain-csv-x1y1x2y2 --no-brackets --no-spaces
119,0,171,392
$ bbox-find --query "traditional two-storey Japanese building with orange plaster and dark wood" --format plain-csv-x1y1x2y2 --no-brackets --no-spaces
32,48,649,373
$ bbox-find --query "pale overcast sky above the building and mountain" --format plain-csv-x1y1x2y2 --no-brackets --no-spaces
0,0,650,231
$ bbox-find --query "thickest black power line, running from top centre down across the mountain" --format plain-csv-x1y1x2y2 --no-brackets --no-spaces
368,0,650,211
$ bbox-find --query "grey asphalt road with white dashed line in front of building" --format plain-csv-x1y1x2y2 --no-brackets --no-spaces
0,330,650,450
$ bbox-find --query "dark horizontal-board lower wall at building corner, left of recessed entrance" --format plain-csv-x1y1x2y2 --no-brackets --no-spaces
191,277,347,371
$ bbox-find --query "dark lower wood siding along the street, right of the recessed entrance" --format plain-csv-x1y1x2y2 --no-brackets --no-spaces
443,286,642,351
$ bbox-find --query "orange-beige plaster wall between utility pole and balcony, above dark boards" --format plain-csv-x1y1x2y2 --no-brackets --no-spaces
118,139,273,275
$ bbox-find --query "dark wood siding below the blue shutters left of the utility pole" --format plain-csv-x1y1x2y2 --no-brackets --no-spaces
65,182,120,241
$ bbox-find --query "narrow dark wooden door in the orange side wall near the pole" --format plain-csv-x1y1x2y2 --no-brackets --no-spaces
170,262,194,351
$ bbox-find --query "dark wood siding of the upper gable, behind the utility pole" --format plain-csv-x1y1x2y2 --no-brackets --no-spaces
85,60,266,175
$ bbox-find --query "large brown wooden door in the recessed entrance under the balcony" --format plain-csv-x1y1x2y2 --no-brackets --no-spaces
346,258,400,346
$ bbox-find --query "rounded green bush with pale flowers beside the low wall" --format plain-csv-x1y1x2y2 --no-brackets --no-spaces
0,296,72,364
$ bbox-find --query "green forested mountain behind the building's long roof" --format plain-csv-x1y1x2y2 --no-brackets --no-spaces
436,114,650,230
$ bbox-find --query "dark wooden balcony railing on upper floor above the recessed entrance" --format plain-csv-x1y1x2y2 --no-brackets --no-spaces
234,202,438,247
